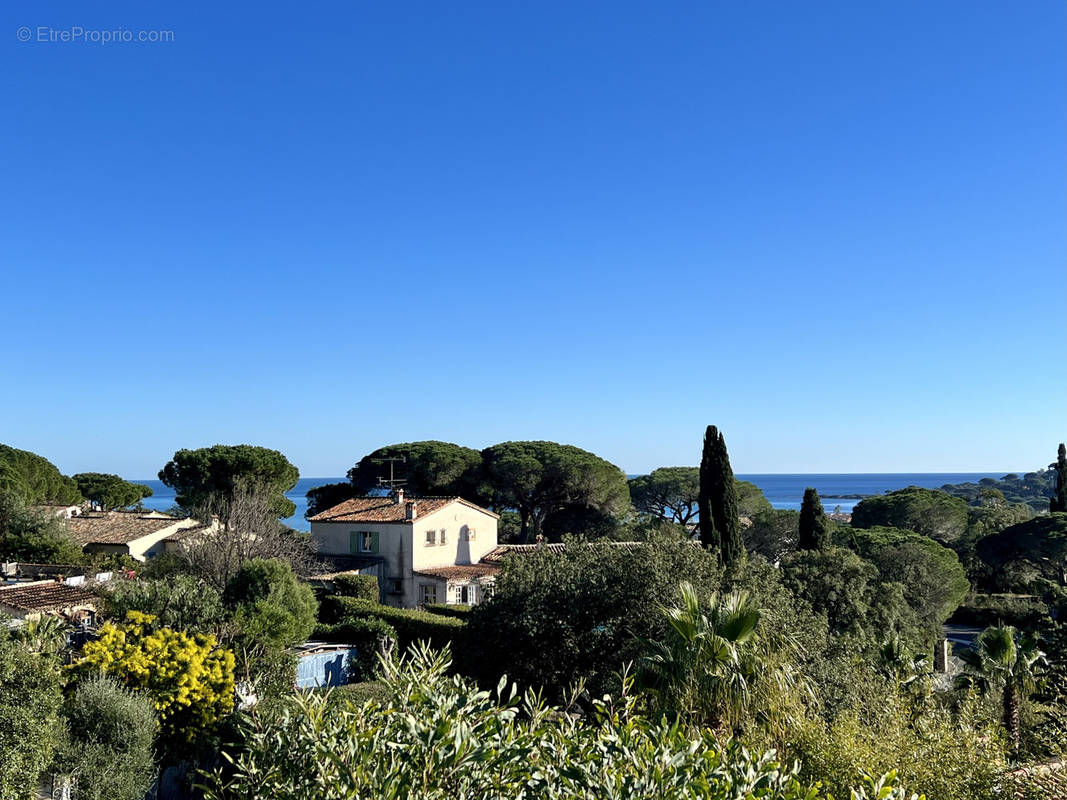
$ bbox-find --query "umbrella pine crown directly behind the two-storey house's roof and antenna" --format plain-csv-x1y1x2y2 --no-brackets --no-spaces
348,441,481,500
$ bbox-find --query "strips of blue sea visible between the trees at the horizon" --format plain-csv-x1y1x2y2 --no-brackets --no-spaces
137,469,1025,530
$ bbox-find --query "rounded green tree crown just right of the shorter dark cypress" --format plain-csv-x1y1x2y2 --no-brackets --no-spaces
851,486,968,544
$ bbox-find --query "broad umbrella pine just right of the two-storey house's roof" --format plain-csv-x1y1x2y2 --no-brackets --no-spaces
481,442,630,542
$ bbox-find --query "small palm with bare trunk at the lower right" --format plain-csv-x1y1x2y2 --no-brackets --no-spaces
956,625,1047,753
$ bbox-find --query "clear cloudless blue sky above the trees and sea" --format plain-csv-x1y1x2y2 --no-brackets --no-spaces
0,0,1067,477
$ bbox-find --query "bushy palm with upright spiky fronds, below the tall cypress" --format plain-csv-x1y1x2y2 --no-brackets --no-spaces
637,582,794,729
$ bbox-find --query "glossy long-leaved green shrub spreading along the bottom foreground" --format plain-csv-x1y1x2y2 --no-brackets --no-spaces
206,649,906,800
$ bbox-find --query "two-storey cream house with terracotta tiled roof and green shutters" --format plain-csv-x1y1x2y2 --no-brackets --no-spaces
310,491,499,608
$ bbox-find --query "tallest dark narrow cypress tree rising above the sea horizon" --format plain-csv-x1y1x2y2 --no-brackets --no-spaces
698,425,745,566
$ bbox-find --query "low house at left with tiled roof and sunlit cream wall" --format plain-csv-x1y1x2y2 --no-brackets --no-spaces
66,511,205,561
